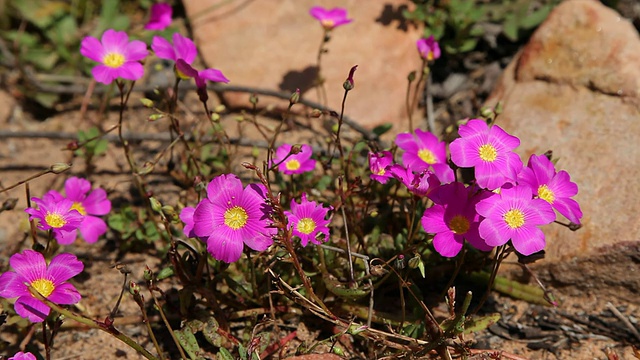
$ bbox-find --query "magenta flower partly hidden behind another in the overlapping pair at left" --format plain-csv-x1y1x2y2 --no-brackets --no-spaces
47,176,111,245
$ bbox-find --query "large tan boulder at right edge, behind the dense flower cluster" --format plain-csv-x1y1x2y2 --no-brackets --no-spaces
487,0,640,299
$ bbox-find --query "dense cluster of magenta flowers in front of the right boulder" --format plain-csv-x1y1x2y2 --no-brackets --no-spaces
369,119,582,257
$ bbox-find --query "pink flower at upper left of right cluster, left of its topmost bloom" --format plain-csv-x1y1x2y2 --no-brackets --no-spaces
396,129,455,183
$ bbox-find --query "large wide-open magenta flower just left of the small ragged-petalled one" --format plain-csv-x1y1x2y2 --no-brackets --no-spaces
193,174,276,263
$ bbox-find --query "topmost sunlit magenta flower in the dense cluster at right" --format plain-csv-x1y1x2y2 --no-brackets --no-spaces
449,119,522,190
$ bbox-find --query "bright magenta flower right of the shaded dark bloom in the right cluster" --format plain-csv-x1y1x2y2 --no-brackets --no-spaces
476,185,556,255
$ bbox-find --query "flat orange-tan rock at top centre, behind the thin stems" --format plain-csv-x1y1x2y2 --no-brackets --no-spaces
183,0,421,132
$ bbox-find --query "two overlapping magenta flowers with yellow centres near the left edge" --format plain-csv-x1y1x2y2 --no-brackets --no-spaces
25,177,111,245
